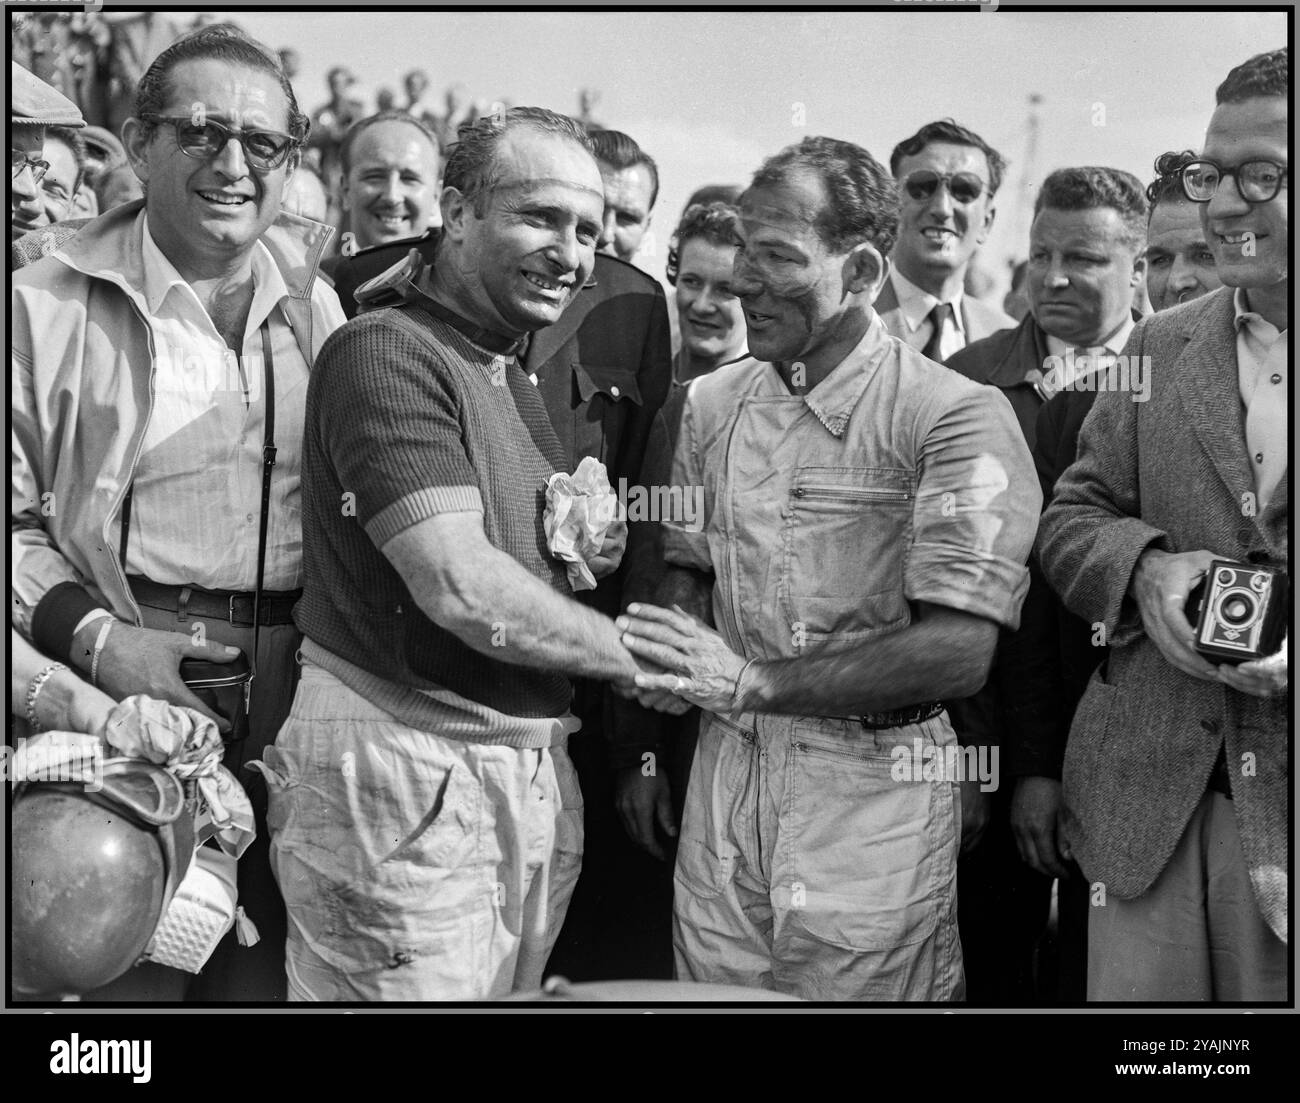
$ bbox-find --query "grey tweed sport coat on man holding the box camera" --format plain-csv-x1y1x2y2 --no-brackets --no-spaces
1037,287,1291,940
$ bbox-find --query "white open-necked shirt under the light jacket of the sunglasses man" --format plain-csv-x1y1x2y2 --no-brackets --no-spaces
126,212,318,591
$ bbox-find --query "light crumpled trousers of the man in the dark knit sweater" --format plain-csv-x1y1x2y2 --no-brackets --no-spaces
265,663,582,1002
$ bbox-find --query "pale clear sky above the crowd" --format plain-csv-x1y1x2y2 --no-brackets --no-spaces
220,7,1287,292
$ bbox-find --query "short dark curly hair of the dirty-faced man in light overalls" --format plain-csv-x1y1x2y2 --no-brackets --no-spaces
746,135,900,255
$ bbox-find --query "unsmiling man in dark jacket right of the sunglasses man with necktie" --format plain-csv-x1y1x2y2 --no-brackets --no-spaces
948,168,1149,1003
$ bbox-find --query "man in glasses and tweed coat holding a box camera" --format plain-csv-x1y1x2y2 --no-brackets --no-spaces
1037,49,1291,1002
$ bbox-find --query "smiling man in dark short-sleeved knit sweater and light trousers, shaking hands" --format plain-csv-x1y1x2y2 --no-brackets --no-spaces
267,108,650,1000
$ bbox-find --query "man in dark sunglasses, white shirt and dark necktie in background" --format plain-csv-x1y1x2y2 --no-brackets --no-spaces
875,118,1015,362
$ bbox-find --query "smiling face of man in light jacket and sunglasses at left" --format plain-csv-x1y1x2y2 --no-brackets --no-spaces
122,59,296,278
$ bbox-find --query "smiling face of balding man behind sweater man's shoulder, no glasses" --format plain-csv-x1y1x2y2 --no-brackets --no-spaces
343,120,438,248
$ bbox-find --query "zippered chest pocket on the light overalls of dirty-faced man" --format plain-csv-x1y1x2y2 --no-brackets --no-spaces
781,467,914,643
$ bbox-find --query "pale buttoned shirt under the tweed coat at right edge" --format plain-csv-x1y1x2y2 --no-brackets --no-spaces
1232,287,1291,510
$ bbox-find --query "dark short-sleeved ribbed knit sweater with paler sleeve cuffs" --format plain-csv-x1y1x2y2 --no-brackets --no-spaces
295,297,571,717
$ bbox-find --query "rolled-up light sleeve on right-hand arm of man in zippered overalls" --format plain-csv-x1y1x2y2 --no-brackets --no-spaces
904,385,1043,628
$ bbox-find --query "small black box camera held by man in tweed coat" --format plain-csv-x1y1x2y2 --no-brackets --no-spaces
1187,559,1290,663
